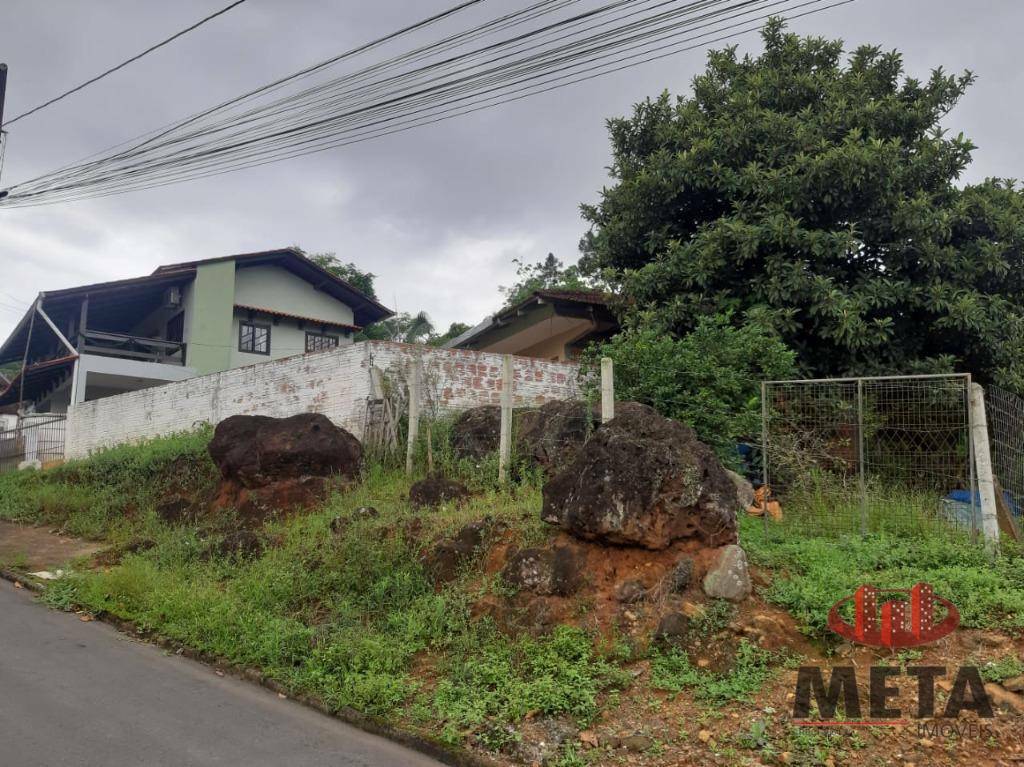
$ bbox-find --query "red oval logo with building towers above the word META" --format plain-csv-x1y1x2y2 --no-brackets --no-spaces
828,583,959,647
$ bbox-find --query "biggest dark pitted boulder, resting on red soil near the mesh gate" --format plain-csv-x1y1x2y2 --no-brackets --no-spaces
541,402,736,549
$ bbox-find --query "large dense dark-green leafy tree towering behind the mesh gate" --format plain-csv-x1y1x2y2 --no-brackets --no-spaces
581,20,1024,389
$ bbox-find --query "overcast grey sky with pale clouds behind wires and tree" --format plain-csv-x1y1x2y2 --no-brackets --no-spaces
0,0,1024,339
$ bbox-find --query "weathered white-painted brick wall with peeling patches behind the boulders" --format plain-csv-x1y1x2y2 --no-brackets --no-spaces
65,341,579,458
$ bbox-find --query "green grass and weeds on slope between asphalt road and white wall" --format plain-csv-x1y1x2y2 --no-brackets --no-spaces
16,433,632,758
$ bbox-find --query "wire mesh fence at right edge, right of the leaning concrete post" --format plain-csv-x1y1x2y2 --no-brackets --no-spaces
985,386,1024,523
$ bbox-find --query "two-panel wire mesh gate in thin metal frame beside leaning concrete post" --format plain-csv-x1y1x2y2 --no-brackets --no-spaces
762,375,978,536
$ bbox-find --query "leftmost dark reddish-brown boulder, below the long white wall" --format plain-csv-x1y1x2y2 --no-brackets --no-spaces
209,413,362,487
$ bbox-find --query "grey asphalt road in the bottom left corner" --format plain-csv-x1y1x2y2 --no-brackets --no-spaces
0,582,438,767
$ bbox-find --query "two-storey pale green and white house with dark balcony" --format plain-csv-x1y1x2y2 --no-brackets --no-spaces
0,248,392,413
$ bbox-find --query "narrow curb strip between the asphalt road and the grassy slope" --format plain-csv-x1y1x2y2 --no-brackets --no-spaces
0,567,501,767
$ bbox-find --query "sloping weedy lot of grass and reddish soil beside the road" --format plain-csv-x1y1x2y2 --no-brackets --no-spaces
0,432,1024,765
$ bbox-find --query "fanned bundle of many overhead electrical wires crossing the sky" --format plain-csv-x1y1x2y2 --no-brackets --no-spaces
0,0,853,207
